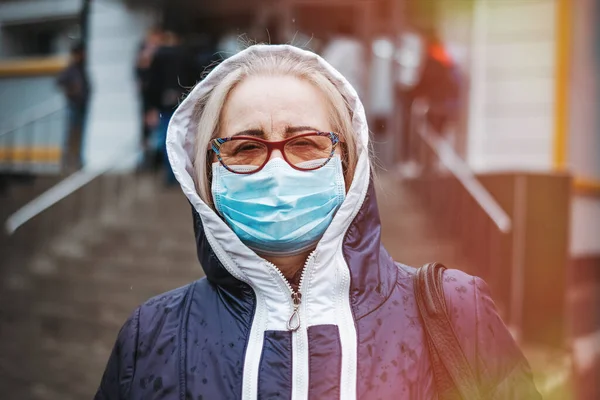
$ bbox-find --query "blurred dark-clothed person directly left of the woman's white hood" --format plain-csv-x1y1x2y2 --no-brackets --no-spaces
146,31,199,185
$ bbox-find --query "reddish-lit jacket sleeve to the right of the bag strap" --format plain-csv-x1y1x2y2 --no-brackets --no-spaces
444,270,542,400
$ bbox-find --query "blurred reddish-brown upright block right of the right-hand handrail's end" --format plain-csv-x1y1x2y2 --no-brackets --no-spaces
478,172,571,348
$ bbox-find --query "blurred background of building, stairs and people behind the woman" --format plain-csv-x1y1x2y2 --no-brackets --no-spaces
0,0,600,400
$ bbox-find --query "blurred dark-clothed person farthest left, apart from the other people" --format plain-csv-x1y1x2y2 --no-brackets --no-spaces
57,42,90,171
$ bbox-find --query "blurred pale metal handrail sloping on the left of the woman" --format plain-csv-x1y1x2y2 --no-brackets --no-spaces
4,150,143,235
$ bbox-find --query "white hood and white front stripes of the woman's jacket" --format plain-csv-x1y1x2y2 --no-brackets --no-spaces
167,45,370,400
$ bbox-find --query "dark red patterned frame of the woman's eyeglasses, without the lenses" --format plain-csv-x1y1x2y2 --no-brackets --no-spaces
208,132,341,175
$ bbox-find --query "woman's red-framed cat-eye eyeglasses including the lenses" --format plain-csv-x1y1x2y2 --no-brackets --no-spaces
209,132,340,174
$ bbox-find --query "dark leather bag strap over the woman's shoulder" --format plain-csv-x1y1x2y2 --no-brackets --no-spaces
414,263,481,400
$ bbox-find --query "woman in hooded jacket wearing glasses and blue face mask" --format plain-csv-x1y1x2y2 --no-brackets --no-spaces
97,45,538,400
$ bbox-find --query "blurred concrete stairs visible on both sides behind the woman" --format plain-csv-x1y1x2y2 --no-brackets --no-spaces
0,171,576,400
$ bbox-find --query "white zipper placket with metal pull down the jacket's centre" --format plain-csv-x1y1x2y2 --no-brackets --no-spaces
268,251,315,400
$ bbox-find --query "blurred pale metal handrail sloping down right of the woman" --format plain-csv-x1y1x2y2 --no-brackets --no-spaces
411,100,512,233
